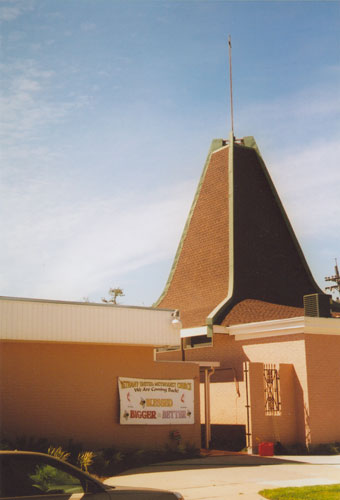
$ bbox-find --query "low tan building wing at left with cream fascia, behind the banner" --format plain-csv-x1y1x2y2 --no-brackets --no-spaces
0,297,201,449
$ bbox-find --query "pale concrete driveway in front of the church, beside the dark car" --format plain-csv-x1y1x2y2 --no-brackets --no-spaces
105,452,340,500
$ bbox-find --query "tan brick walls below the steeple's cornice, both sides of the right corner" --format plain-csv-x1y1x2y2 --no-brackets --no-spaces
158,334,340,446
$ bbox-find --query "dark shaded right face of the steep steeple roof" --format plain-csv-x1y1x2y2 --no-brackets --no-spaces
230,145,318,310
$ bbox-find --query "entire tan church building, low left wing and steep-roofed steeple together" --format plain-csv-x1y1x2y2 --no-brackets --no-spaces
0,136,340,451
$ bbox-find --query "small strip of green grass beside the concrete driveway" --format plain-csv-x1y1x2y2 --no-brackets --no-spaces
259,484,340,500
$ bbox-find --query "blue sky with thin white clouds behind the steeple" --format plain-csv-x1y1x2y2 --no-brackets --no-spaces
0,0,340,306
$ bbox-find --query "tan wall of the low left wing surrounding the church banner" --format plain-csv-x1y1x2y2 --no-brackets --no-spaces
0,341,200,449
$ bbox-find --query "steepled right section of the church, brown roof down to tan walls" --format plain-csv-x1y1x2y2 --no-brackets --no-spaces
157,135,340,451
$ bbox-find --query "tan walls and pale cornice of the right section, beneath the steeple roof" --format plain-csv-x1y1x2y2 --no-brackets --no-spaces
158,317,340,451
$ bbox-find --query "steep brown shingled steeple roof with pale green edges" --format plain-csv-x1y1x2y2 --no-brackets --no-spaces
156,136,321,327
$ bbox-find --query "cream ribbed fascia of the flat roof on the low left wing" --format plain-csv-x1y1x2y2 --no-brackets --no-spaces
0,297,180,347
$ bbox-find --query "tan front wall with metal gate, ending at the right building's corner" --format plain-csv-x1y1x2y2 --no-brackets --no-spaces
161,334,308,446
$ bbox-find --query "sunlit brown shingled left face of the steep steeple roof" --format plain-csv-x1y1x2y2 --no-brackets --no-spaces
158,147,229,327
